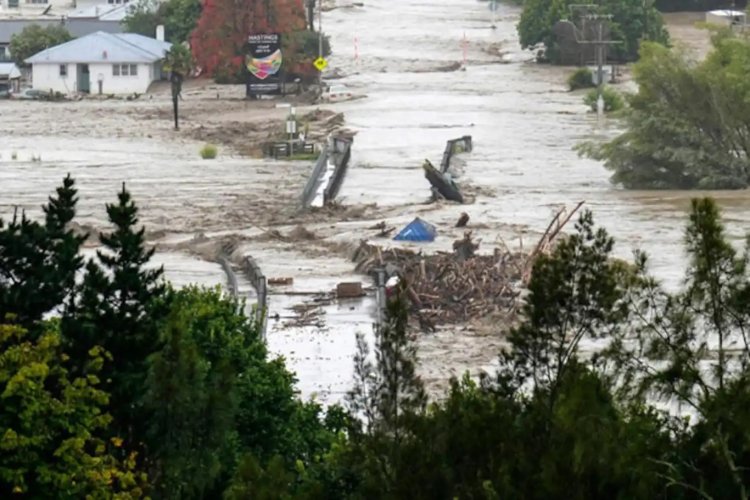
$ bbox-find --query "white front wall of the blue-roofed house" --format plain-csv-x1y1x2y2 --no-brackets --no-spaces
32,63,154,94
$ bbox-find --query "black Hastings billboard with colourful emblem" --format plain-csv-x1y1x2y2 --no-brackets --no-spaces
245,33,283,95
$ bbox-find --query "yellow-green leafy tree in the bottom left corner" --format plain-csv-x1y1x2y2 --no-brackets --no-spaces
0,323,145,498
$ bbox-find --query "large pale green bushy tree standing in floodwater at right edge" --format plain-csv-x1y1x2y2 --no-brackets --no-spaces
583,32,750,189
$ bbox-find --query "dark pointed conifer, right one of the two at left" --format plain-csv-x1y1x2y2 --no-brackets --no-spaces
63,184,167,445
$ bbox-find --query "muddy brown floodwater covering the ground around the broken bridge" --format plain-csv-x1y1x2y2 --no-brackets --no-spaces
0,0,750,402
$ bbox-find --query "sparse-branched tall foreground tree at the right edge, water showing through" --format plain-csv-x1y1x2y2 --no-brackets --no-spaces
614,199,750,498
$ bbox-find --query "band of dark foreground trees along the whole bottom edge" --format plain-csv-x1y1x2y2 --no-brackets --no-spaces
0,178,750,500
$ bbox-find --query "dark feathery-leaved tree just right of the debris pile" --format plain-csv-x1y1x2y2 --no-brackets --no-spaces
500,211,630,402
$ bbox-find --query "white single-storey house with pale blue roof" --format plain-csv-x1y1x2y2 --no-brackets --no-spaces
26,31,171,94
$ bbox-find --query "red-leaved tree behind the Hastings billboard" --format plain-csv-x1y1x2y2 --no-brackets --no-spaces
190,0,306,79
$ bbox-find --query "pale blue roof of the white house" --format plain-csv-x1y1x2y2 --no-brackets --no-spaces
25,31,172,64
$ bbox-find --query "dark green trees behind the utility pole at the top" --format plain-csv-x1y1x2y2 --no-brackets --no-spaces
518,0,669,63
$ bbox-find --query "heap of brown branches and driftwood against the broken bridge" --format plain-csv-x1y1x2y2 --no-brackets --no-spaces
353,232,527,324
